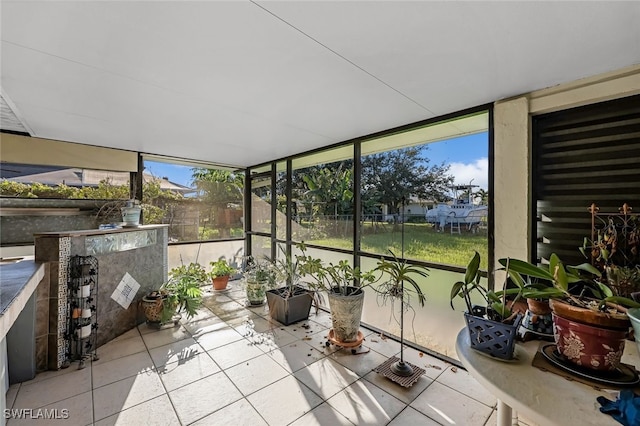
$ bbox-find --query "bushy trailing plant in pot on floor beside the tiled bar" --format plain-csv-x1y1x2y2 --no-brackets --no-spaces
142,263,206,325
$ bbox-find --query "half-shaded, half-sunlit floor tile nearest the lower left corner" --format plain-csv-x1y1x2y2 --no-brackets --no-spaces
93,371,165,421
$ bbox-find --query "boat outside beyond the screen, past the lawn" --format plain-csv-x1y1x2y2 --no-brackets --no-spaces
425,183,489,233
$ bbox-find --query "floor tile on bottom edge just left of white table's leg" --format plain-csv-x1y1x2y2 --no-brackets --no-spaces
411,382,493,426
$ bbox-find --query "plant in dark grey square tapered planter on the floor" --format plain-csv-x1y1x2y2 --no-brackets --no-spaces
267,245,317,325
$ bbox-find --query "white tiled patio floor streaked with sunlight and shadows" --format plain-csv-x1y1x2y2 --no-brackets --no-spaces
7,282,528,426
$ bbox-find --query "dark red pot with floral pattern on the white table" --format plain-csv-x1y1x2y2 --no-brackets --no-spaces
553,313,627,371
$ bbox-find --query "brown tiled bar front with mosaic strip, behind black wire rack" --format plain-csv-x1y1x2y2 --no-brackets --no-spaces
35,225,168,370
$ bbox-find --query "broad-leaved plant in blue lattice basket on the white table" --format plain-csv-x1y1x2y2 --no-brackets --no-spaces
451,252,522,360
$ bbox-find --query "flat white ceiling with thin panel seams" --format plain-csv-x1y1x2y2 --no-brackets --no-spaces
0,0,640,166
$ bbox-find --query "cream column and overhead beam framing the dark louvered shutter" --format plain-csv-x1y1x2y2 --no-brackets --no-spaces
493,65,640,272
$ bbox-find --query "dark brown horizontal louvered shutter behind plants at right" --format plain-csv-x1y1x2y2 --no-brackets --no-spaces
532,95,640,264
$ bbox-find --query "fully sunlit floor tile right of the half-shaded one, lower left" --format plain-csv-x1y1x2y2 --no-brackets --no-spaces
169,372,242,424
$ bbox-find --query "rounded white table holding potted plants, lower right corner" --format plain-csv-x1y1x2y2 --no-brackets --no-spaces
456,327,640,426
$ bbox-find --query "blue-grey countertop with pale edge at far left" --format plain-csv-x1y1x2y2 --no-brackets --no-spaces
0,256,44,339
